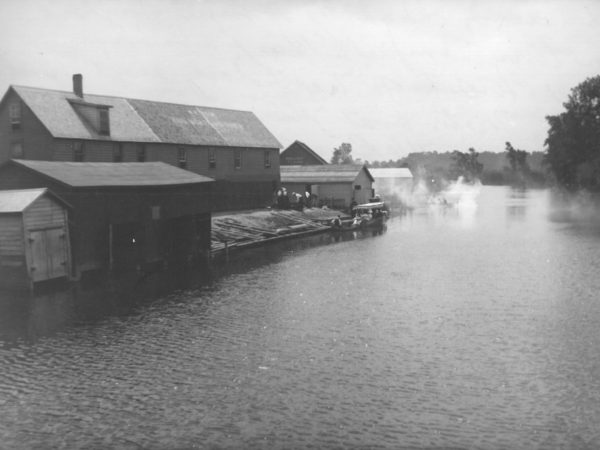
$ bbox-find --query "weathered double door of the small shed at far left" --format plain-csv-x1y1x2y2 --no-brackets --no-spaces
28,228,68,281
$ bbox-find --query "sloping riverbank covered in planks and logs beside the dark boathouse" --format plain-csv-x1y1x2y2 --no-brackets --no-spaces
211,208,350,257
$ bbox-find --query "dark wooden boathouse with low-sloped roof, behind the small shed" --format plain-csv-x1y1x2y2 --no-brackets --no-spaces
0,160,213,278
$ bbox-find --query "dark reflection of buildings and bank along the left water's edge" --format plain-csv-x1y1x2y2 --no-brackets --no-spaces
0,226,387,345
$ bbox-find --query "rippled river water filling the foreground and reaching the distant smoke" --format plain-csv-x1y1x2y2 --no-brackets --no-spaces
0,187,600,449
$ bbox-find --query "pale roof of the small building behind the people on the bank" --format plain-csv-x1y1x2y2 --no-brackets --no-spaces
280,164,374,183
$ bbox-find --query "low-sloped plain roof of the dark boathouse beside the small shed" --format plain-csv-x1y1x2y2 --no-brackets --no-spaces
8,159,214,187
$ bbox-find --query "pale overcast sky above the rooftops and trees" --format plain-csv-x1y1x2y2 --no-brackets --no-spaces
0,0,600,161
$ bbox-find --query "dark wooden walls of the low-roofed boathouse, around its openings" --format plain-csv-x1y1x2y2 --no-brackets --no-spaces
0,165,213,273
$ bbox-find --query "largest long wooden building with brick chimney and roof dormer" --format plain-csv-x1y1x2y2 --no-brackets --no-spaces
0,75,281,210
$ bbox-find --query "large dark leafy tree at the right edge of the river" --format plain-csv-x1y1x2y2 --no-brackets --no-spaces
545,75,600,192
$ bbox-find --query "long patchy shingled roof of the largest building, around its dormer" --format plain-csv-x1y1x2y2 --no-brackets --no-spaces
11,86,281,148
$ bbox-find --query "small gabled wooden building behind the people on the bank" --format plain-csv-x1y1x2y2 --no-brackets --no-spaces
280,164,374,209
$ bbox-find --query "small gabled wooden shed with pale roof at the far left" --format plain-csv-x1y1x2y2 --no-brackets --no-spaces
0,188,71,288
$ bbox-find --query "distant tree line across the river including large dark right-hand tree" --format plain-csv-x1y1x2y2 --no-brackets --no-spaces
331,75,600,192
